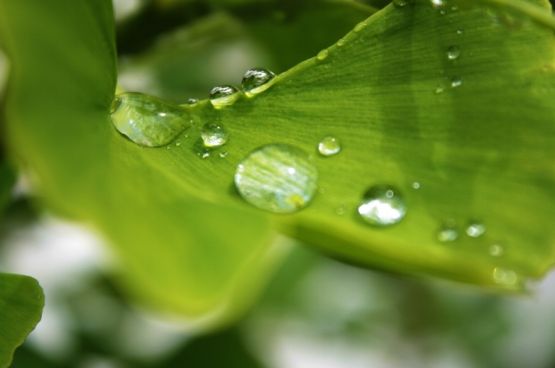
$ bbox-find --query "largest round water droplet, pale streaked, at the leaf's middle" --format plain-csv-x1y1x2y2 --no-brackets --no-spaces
235,144,318,213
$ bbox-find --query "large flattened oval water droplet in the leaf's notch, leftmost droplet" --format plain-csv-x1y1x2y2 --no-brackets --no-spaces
111,92,190,147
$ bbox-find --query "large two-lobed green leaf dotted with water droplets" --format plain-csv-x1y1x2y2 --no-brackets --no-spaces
0,0,555,364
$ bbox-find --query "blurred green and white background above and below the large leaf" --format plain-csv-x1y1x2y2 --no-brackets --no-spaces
0,0,555,368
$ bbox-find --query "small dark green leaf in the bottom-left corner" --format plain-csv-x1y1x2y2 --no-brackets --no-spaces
0,273,44,367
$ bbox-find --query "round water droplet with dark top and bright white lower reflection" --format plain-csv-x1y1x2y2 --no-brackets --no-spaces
358,185,407,227
